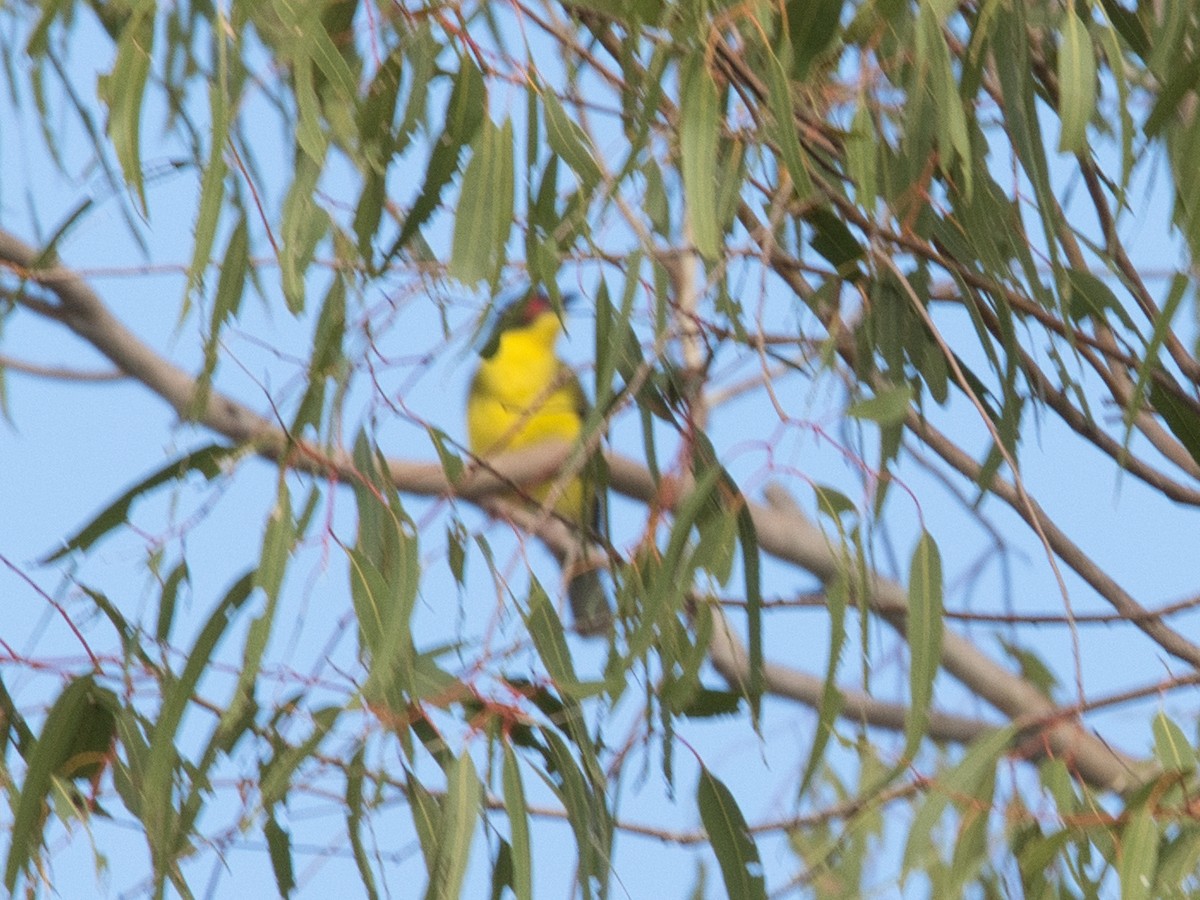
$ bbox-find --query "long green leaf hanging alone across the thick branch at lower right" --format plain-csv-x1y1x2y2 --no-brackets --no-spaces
905,532,942,756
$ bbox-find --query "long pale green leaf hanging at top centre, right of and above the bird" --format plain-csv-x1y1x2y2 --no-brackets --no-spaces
679,53,720,259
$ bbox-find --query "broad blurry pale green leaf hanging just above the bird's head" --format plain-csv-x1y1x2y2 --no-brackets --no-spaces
450,120,514,284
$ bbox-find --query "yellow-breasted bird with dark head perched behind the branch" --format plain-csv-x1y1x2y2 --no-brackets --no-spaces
467,290,612,635
